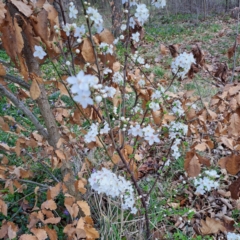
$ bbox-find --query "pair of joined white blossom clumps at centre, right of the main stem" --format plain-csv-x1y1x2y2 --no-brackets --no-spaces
128,124,160,146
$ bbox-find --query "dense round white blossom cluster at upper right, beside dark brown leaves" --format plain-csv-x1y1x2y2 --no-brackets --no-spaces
171,52,196,79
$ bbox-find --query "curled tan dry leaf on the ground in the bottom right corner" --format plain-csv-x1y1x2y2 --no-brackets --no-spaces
200,217,226,235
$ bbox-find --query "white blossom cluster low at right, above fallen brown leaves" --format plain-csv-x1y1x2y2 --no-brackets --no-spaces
193,170,219,195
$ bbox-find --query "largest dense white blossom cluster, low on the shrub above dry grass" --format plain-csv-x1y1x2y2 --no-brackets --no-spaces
88,168,137,214
